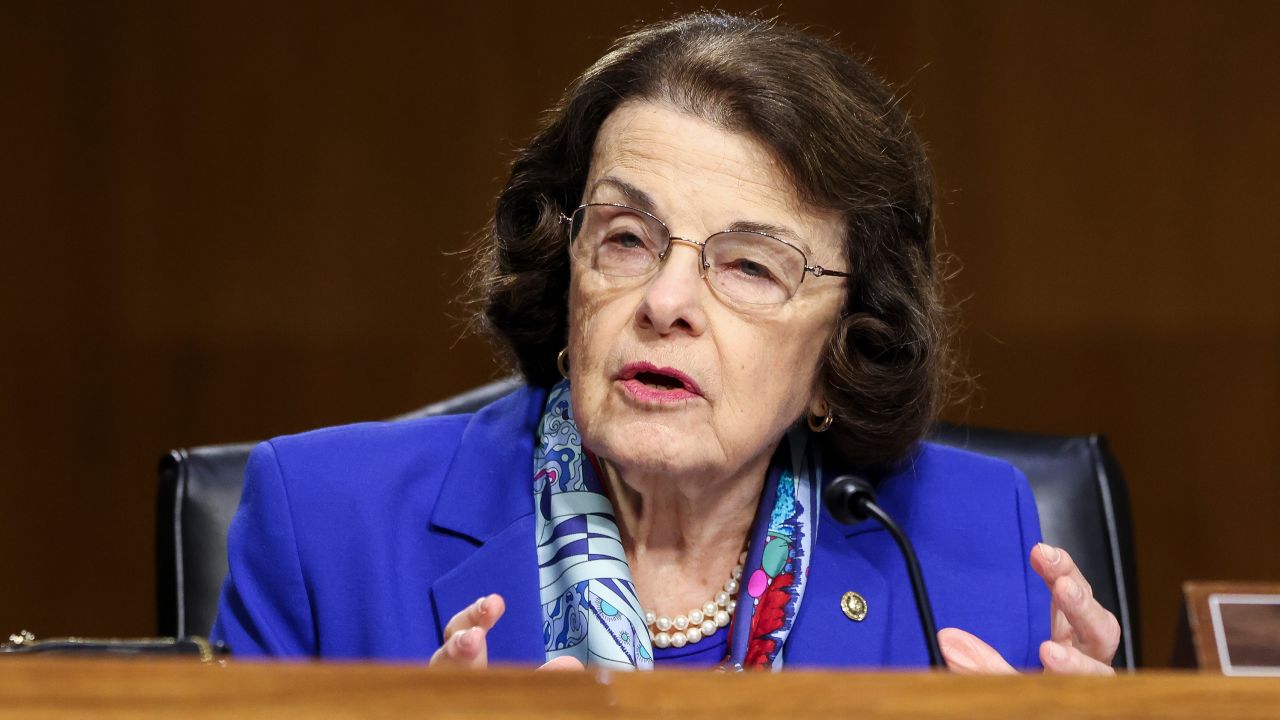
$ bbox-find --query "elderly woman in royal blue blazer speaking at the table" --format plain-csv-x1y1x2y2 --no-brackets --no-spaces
214,14,1117,671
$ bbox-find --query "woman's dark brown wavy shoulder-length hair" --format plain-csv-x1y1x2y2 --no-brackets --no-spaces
471,13,950,468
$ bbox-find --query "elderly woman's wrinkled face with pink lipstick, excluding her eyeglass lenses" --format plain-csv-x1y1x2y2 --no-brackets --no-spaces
568,101,847,489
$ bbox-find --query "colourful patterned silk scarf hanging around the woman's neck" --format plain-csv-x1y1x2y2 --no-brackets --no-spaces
534,380,822,670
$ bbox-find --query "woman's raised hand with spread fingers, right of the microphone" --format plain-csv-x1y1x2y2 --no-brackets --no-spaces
938,543,1120,675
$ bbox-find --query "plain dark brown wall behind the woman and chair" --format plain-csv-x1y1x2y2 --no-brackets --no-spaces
0,0,1280,664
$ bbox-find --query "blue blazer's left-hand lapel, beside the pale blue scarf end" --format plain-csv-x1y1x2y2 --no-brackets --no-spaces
430,387,547,664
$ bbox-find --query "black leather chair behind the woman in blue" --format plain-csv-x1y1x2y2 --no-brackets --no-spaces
156,379,1138,670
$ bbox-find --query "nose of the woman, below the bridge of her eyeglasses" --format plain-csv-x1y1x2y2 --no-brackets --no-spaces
636,237,708,336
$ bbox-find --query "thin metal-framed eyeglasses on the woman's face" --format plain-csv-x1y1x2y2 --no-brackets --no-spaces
561,202,850,305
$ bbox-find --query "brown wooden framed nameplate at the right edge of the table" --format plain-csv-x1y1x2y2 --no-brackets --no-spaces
1183,582,1280,676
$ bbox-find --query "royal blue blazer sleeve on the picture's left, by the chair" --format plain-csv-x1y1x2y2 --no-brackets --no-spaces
210,442,317,657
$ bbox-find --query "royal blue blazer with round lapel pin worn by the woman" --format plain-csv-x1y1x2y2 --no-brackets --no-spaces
211,387,1050,667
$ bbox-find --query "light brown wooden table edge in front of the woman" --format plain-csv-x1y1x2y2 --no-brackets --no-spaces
0,657,1280,720
